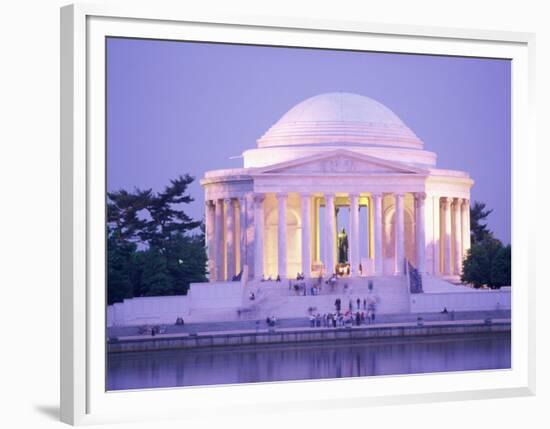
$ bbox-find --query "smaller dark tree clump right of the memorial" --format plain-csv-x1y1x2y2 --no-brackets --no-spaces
461,201,512,288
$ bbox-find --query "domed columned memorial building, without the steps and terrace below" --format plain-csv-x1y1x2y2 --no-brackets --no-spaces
201,92,474,282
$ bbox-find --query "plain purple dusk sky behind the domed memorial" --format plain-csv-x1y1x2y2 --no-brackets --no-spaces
107,38,511,243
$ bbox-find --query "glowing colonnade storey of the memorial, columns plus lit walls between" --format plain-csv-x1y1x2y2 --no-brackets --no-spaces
207,192,469,280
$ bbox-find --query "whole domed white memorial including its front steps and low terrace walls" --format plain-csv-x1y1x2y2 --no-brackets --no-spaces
107,93,511,326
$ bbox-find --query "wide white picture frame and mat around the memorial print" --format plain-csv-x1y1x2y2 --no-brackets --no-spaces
61,5,536,424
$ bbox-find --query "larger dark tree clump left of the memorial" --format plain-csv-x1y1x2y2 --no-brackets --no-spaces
107,174,207,304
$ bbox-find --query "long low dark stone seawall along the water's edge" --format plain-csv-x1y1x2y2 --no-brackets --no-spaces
107,319,511,353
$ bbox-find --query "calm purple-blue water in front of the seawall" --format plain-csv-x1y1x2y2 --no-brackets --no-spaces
107,333,511,390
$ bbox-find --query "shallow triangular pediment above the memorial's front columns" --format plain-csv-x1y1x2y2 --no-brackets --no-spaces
256,150,432,175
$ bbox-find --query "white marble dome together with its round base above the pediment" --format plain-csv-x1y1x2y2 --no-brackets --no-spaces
242,92,437,168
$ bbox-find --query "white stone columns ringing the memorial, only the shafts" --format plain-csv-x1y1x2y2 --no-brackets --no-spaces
206,193,470,281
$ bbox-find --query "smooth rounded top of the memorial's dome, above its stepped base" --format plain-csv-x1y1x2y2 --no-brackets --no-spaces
258,92,423,149
